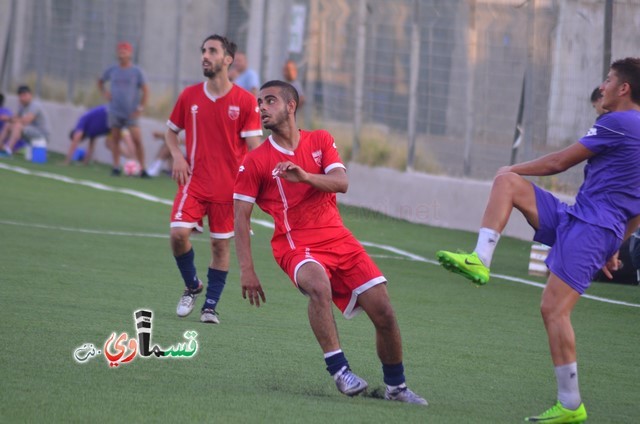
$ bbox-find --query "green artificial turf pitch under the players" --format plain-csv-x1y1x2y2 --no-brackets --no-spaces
0,158,640,423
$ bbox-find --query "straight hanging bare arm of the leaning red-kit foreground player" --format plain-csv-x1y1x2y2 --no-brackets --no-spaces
233,200,267,307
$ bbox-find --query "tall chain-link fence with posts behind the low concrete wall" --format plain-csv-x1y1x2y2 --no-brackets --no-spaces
0,0,640,191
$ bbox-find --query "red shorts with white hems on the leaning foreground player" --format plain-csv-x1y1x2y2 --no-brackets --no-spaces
276,236,387,318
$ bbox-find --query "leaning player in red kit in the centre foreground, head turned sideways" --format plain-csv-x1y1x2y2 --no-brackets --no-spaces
233,81,427,405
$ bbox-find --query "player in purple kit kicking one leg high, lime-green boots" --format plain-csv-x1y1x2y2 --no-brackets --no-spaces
437,58,640,423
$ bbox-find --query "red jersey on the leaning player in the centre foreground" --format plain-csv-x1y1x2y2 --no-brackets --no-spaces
233,130,351,258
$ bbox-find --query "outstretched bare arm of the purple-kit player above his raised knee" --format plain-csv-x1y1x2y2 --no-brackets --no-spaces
496,143,594,176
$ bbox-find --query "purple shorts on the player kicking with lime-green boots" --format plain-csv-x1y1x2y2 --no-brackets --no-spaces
533,184,622,294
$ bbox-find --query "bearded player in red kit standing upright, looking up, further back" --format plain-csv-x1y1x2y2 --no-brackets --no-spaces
166,35,262,324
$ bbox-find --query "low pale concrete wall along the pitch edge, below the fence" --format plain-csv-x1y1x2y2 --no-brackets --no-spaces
6,96,573,240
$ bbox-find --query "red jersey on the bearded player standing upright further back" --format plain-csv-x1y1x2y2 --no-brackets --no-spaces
167,82,262,202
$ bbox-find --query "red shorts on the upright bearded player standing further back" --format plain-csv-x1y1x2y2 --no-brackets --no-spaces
171,191,233,239
